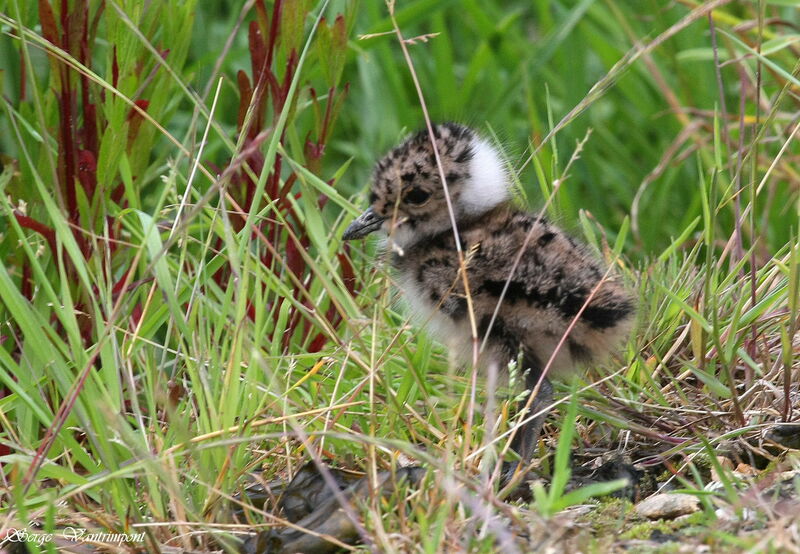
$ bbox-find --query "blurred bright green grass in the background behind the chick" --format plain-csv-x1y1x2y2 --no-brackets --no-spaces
0,0,800,254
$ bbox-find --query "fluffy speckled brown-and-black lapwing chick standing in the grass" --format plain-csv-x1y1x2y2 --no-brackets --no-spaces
342,123,634,474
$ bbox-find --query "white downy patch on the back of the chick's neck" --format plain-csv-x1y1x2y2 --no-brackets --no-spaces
459,137,510,215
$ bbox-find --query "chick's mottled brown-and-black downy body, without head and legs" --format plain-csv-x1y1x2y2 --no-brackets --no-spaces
393,204,634,375
